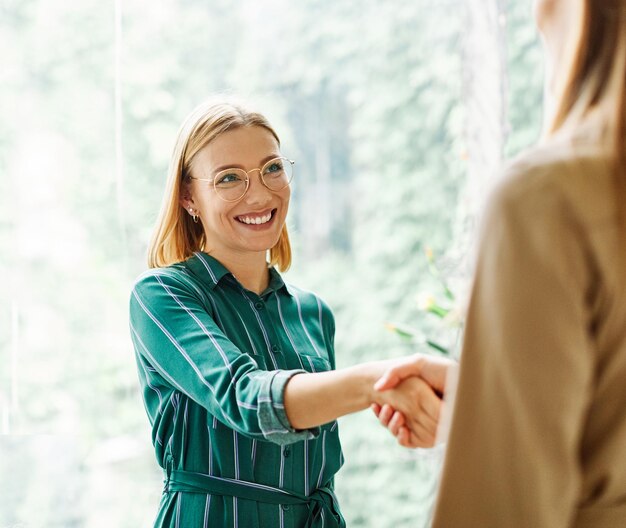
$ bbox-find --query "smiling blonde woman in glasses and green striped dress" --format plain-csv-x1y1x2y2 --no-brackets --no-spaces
130,100,446,528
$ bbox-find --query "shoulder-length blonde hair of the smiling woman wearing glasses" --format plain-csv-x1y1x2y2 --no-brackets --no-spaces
148,98,291,271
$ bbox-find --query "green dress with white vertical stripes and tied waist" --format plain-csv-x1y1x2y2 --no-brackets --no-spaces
130,253,344,528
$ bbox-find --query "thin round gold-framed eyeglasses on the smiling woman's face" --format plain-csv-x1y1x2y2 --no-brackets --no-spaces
189,158,295,202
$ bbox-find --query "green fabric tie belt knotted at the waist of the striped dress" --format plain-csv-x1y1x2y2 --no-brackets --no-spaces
165,469,346,528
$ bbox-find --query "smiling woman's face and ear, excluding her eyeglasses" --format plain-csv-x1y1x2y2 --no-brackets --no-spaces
181,126,291,258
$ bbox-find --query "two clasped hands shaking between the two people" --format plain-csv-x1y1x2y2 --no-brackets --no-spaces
371,354,456,448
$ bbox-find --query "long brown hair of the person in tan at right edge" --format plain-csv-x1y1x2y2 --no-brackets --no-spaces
548,0,626,223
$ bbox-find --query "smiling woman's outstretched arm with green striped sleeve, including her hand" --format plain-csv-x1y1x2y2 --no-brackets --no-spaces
130,270,440,446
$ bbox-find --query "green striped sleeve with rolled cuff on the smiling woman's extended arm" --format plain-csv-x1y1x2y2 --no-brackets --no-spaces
130,270,318,444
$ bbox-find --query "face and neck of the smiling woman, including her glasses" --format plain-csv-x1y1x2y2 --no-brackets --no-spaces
180,125,291,284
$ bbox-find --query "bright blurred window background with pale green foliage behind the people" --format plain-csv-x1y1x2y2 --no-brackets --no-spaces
0,0,543,528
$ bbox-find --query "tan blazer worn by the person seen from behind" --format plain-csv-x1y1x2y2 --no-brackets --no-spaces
433,140,626,528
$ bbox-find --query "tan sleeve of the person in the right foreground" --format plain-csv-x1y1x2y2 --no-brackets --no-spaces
433,171,593,528
